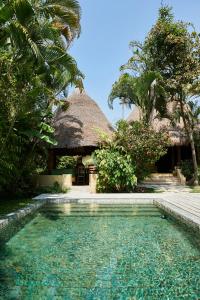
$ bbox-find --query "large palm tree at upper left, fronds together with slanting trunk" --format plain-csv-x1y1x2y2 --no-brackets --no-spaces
0,0,83,169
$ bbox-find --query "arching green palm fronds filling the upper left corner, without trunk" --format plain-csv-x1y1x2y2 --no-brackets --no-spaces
0,0,83,93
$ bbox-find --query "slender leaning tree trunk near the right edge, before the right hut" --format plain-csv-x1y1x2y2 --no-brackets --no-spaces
179,99,199,185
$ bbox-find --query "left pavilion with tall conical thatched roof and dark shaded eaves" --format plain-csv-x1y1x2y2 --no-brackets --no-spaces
48,89,113,184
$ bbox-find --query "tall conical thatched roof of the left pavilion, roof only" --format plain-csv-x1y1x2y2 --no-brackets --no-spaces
54,89,113,149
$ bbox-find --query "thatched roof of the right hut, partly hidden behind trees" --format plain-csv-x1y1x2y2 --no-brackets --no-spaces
127,103,188,146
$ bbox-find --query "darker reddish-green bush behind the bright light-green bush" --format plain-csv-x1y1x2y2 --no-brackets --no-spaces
115,121,169,181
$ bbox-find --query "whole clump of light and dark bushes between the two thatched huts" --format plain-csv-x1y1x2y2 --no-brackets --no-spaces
95,121,169,192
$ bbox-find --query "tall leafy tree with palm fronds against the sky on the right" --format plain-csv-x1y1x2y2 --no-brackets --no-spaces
109,6,200,182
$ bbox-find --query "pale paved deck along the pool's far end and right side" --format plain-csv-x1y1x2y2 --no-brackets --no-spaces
35,188,200,232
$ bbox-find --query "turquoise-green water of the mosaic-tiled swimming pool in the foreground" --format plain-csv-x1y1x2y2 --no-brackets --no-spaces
0,204,200,300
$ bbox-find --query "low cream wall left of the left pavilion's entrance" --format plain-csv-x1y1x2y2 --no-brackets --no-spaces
36,174,72,190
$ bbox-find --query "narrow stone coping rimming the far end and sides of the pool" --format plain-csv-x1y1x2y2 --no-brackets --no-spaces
0,194,200,233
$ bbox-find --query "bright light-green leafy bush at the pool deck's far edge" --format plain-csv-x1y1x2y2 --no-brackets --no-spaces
95,147,137,192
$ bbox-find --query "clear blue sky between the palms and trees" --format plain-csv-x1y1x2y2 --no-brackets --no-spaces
71,0,200,123
